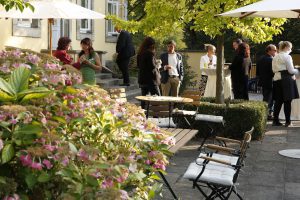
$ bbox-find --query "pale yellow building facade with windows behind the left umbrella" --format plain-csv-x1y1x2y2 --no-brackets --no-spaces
0,0,127,63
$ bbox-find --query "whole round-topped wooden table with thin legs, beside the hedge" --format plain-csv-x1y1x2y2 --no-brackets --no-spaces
135,96,193,127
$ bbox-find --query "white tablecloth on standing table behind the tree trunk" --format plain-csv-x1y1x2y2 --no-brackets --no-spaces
201,68,233,98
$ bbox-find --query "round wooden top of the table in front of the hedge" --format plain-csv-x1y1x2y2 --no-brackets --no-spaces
135,96,193,103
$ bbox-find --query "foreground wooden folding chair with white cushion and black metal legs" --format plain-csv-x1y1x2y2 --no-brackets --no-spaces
183,128,251,200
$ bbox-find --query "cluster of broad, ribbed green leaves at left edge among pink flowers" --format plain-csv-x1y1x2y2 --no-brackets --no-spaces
0,67,51,102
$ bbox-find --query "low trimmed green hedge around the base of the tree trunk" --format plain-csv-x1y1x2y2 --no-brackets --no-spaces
174,98,267,140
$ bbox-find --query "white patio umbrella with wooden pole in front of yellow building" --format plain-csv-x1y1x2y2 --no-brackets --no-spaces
0,0,105,54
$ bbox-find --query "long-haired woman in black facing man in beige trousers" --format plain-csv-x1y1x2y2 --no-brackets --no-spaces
137,37,161,109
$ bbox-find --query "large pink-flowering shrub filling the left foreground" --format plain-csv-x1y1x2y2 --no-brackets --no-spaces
0,49,174,200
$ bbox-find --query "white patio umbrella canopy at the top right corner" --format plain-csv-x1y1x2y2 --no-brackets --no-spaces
220,0,300,18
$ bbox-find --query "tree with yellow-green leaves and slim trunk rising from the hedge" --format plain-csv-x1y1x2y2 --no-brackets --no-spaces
113,0,285,103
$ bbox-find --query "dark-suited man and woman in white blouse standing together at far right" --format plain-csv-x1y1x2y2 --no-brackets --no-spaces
257,41,299,127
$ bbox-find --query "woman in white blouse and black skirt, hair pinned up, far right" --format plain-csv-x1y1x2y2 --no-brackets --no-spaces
272,41,299,127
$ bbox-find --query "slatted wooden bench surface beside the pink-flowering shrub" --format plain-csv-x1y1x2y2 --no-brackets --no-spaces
161,128,198,153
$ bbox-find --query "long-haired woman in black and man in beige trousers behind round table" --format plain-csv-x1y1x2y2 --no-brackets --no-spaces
137,37,184,107
